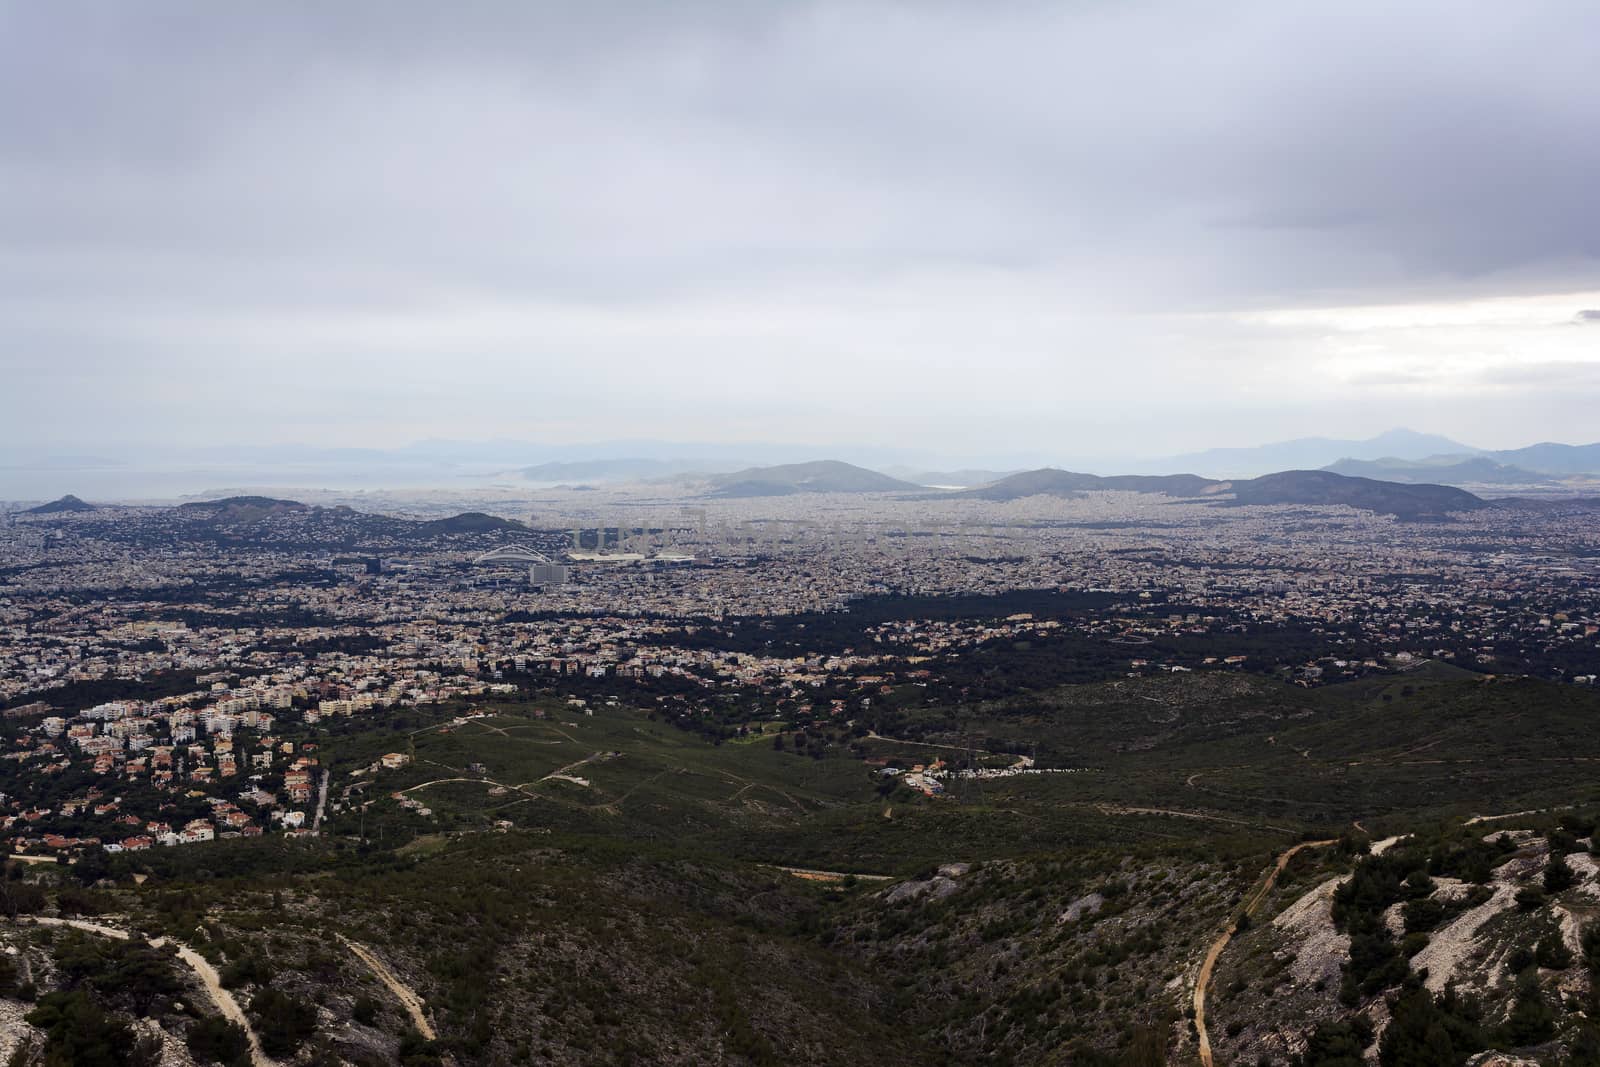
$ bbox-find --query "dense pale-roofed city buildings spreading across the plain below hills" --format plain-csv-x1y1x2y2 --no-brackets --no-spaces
0,493,1600,851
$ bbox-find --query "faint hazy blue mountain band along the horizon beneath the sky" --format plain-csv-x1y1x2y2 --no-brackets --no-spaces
18,429,1600,514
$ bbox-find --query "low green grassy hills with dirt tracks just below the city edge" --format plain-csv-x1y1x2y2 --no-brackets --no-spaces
305,670,1600,873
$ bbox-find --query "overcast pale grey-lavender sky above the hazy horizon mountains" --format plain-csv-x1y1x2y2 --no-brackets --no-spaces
0,0,1600,459
